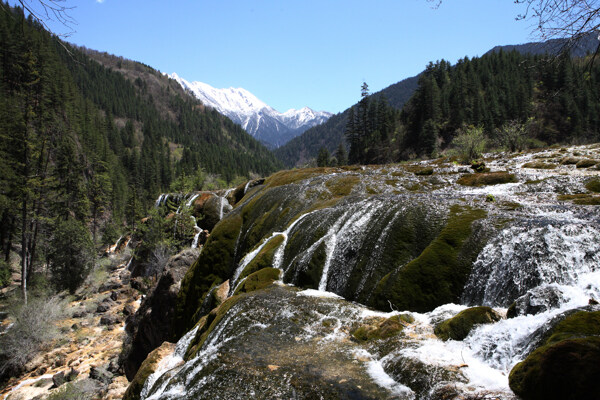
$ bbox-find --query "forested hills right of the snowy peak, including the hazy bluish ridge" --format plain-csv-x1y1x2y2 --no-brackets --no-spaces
276,49,600,166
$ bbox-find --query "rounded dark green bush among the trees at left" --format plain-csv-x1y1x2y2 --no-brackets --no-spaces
48,219,95,293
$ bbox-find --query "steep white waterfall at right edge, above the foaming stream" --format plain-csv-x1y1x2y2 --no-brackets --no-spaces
463,220,600,307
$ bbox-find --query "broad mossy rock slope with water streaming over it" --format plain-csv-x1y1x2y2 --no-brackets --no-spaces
137,146,600,399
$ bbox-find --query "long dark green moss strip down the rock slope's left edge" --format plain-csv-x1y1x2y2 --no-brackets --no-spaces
174,214,242,338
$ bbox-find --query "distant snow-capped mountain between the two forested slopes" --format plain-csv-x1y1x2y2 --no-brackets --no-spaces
169,73,332,148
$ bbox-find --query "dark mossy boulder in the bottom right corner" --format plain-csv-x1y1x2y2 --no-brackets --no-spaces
509,311,600,400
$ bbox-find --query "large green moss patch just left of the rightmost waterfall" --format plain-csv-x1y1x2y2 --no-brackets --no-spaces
373,205,486,312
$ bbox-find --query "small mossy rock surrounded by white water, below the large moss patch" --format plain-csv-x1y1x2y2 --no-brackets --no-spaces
434,307,501,340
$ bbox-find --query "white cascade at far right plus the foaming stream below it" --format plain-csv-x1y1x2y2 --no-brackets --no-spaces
387,213,600,398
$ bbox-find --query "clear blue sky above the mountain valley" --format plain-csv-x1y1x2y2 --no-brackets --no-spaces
28,0,534,112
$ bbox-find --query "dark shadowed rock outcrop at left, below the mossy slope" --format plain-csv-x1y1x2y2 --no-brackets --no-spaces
123,249,200,380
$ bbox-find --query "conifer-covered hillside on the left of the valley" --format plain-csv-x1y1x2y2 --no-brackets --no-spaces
0,4,279,294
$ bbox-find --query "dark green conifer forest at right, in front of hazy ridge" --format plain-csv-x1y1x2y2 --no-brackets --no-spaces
396,51,600,159
